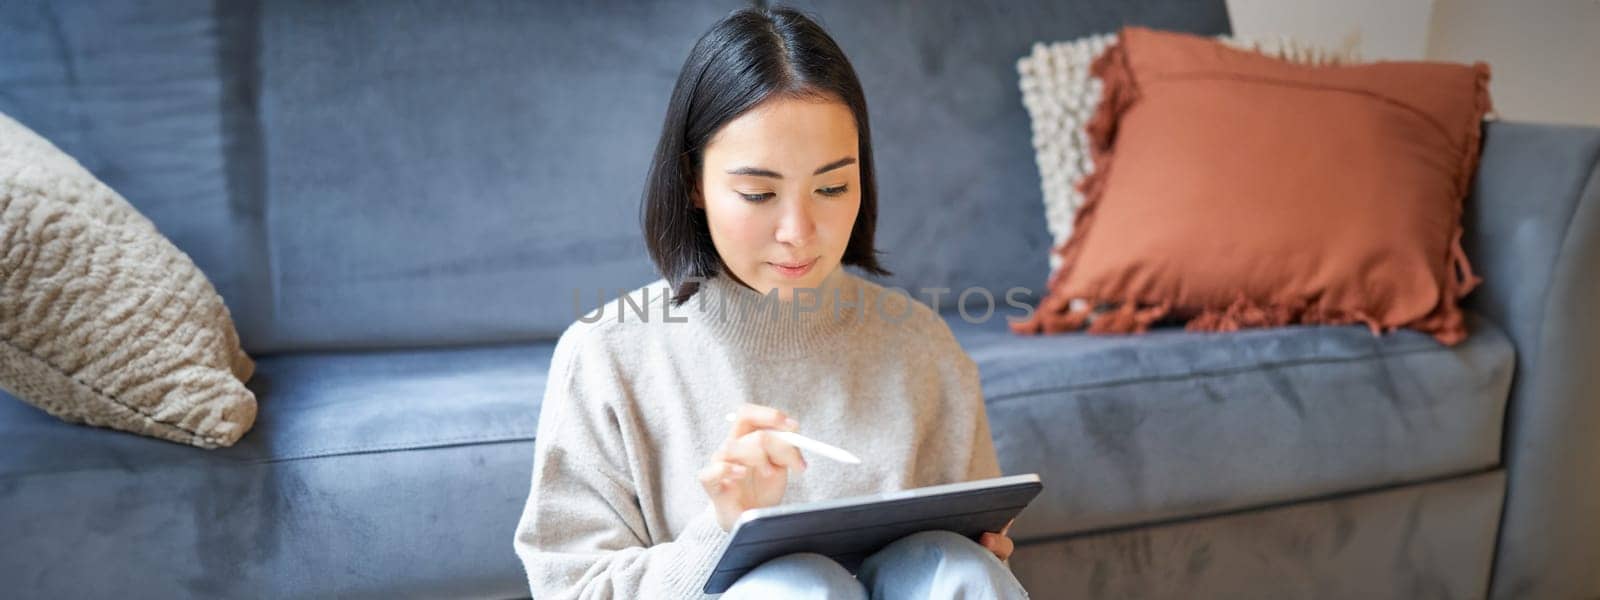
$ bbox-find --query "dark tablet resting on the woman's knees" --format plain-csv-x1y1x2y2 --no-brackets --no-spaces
704,474,1043,594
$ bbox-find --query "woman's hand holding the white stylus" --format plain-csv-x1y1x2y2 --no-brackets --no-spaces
699,405,806,531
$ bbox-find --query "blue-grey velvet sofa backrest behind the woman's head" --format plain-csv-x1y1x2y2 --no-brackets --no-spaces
0,0,1227,352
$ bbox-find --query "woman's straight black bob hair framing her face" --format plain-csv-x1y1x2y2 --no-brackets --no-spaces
642,6,890,304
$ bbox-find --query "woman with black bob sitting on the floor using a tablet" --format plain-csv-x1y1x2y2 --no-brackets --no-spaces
515,10,1026,600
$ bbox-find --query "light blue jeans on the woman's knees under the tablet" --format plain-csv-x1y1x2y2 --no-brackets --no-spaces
722,531,1027,600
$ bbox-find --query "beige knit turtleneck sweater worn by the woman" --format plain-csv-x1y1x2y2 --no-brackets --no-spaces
515,269,1000,600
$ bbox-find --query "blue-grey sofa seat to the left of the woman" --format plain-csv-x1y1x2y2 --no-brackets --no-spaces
0,342,554,597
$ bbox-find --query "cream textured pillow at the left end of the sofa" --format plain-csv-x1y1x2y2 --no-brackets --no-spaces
0,114,256,448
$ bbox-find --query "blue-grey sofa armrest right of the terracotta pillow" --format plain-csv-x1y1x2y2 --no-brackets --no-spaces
1464,122,1600,598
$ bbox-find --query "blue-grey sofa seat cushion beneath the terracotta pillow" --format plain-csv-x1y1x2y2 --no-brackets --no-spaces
946,314,1514,541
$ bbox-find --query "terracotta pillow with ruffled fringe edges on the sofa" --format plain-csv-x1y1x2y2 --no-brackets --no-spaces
1013,27,1490,344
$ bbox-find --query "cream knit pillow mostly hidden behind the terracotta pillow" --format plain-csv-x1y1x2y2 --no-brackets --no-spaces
1016,34,1360,270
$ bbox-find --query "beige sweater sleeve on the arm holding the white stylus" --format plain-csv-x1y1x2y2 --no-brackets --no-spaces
514,330,728,600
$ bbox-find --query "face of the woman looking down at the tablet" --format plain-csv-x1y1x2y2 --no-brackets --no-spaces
694,98,861,299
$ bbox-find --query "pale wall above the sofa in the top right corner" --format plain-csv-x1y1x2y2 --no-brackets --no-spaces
1227,0,1600,125
